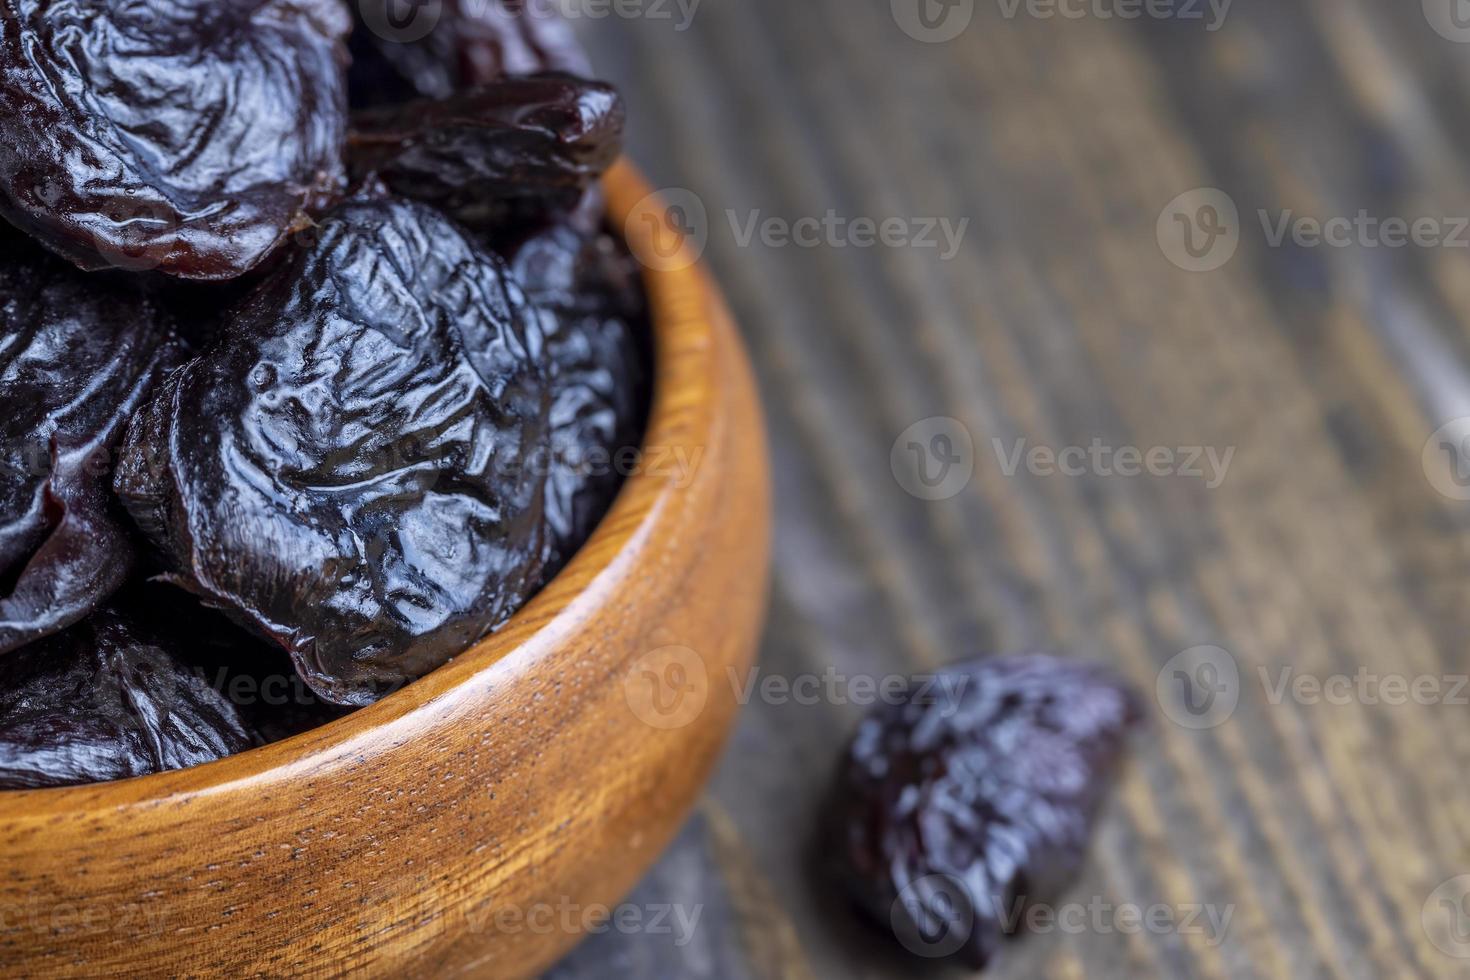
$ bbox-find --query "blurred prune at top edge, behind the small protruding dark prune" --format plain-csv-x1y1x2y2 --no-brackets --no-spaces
350,0,591,106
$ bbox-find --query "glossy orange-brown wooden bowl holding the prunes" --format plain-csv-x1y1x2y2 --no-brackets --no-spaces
0,166,770,977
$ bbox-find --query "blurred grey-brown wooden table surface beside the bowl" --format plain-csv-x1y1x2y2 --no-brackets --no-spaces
551,0,1470,980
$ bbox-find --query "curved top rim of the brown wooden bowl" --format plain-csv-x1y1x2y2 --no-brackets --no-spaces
0,157,705,805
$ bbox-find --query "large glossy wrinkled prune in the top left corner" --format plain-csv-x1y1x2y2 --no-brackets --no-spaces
0,0,351,281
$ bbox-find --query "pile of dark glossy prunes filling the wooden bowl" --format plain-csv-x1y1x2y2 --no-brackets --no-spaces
0,0,650,789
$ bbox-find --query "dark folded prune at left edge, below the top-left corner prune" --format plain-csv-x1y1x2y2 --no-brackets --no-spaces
0,249,181,654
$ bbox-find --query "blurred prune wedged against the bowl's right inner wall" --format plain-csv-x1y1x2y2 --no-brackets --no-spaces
507,218,651,574
